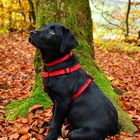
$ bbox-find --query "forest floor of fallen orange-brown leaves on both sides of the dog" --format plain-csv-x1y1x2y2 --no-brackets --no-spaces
0,33,140,140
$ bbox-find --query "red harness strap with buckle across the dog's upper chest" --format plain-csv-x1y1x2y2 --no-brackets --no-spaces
42,64,81,78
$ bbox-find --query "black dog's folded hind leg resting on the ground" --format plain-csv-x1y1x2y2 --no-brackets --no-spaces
68,127,103,140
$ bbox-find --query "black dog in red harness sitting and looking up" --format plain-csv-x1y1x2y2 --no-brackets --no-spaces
29,23,119,140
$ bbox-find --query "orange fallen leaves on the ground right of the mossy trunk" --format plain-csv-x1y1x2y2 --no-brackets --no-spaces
95,44,140,140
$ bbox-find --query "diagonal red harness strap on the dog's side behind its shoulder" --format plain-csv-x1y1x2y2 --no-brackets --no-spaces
72,78,92,100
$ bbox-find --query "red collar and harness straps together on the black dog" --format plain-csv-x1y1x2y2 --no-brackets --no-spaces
42,52,92,100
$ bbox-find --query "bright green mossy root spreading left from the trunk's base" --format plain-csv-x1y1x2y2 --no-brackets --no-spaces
5,94,51,120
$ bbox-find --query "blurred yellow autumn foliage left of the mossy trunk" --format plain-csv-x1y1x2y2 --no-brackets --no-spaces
0,0,36,32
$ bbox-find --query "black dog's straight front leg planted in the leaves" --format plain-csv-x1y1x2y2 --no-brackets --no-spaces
44,98,70,140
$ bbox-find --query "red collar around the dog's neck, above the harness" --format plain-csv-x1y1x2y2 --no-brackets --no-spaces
45,52,72,67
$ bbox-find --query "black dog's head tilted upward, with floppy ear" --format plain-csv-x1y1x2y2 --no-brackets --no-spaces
29,23,77,53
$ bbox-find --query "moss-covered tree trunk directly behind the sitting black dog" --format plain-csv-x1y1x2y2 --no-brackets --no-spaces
5,0,136,134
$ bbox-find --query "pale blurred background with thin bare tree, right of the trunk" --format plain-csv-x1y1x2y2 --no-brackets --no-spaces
92,0,140,39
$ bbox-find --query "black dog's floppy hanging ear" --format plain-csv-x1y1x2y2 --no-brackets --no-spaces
60,29,78,53
